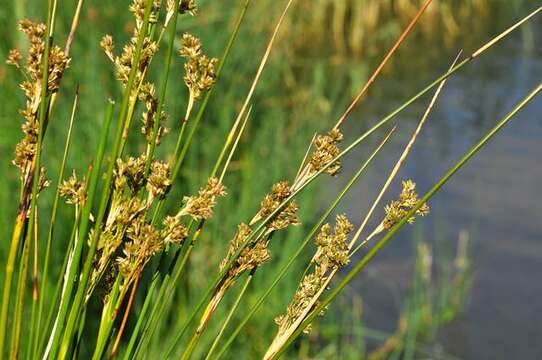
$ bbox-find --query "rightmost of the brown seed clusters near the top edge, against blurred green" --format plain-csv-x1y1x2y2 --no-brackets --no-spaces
179,34,218,100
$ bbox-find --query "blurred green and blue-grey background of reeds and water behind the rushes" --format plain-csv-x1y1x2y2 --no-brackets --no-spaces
0,0,542,359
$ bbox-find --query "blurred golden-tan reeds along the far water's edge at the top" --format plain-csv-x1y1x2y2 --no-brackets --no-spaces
257,0,524,59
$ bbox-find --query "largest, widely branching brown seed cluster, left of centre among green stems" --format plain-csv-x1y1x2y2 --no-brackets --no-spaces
90,155,188,289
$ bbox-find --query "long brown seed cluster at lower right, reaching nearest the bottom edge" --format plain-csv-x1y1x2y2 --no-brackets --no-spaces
275,215,353,336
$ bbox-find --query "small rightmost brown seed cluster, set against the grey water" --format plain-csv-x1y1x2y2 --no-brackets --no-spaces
382,180,429,230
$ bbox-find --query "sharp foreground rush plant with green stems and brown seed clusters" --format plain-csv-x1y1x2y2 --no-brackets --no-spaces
0,0,542,359
